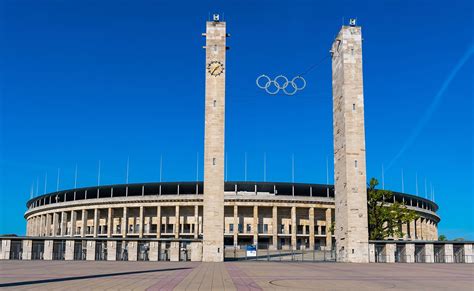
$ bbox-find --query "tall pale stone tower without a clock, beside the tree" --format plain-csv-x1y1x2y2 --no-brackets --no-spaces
331,25,369,263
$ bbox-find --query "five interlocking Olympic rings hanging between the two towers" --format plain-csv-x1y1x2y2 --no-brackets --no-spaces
255,75,306,96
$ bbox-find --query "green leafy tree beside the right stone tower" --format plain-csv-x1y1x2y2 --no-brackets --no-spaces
367,178,418,240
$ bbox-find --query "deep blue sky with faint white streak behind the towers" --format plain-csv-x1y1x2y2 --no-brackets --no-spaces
0,0,474,239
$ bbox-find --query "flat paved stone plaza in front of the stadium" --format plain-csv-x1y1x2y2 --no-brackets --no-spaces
0,261,474,290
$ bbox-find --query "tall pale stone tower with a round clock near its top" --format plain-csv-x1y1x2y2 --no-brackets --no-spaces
202,15,227,262
